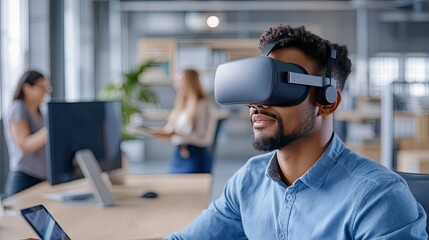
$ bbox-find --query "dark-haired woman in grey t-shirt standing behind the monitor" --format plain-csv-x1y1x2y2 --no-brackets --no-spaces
5,71,52,197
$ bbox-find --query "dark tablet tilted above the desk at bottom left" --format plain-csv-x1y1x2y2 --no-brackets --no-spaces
21,205,70,240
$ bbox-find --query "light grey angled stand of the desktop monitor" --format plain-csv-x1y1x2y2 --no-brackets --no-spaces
66,149,115,207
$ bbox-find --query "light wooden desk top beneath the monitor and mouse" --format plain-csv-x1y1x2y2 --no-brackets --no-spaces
0,174,211,239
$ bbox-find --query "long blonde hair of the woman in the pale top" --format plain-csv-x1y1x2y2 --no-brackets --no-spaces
168,69,208,126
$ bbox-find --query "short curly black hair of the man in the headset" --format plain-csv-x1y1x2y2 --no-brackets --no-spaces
259,24,352,91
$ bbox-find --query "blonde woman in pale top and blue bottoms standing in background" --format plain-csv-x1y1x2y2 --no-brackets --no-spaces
153,69,216,173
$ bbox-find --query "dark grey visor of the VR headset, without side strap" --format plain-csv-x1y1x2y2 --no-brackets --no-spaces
214,56,310,106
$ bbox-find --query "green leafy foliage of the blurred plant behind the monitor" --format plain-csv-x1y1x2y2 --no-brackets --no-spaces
99,60,158,140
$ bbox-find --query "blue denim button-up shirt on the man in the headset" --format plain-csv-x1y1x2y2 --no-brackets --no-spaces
166,135,427,240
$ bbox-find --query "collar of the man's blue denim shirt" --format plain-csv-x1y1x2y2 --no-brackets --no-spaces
266,133,344,189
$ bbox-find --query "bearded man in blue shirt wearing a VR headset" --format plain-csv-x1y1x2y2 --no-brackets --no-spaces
163,25,427,240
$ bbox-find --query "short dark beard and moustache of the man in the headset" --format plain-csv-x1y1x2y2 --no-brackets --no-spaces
253,105,316,152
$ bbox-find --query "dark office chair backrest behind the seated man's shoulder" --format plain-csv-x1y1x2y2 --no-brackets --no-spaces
397,172,429,234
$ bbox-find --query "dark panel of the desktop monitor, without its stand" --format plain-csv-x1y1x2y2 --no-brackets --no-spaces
46,101,122,185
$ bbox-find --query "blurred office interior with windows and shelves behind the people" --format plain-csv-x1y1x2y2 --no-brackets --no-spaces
0,0,429,199
